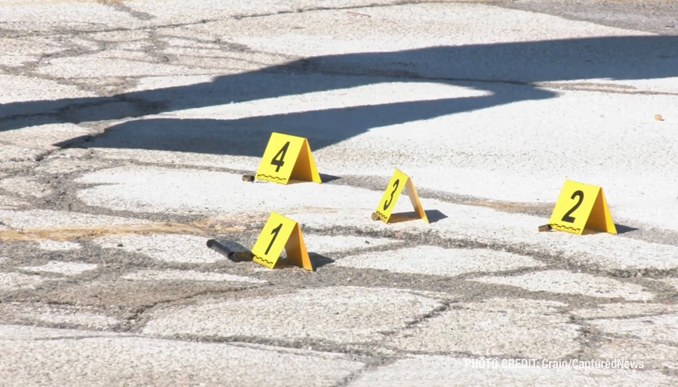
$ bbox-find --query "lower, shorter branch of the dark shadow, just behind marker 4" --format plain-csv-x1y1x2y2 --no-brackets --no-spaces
56,85,554,157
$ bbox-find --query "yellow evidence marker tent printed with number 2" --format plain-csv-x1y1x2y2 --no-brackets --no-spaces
549,180,617,235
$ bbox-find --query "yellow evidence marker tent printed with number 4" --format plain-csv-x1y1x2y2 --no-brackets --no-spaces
255,132,322,184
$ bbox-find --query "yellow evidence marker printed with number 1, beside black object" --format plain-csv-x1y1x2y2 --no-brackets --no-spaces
252,212,313,271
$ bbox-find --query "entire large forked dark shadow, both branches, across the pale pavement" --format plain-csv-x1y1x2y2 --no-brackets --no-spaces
0,36,678,156
